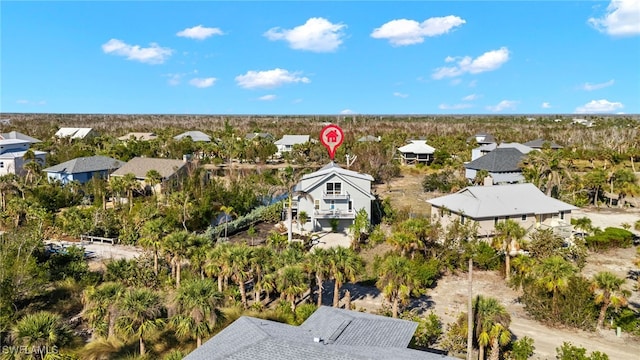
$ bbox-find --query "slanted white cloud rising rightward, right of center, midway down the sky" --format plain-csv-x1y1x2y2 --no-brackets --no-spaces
432,46,509,80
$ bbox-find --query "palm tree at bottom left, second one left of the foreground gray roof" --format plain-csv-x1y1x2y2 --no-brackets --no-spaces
116,288,165,356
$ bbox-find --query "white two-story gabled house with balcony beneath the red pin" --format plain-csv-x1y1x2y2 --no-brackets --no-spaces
295,161,375,231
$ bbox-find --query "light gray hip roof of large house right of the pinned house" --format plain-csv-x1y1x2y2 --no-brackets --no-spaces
427,184,578,219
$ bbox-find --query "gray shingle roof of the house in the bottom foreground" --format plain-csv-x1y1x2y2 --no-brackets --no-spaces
185,306,453,360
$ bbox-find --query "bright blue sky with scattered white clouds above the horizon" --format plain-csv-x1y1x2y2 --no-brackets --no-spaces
0,0,640,114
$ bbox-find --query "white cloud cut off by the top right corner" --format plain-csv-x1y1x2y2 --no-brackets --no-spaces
588,0,640,36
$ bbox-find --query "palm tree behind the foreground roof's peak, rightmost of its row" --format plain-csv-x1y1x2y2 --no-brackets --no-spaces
329,246,364,307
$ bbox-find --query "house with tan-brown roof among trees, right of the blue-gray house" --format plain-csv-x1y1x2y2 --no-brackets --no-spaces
111,157,188,193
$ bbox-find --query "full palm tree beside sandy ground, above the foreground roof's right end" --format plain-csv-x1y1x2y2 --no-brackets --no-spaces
376,254,420,318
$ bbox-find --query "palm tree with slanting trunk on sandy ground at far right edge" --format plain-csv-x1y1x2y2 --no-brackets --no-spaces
591,271,631,329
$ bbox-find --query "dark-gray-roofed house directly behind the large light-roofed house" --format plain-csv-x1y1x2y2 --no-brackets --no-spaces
464,147,526,184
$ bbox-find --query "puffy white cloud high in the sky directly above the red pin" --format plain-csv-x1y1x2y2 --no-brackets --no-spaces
264,18,347,52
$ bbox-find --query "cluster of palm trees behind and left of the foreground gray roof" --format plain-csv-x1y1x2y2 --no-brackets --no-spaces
83,226,364,354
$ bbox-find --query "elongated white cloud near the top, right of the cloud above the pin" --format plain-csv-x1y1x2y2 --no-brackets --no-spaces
371,15,466,46
